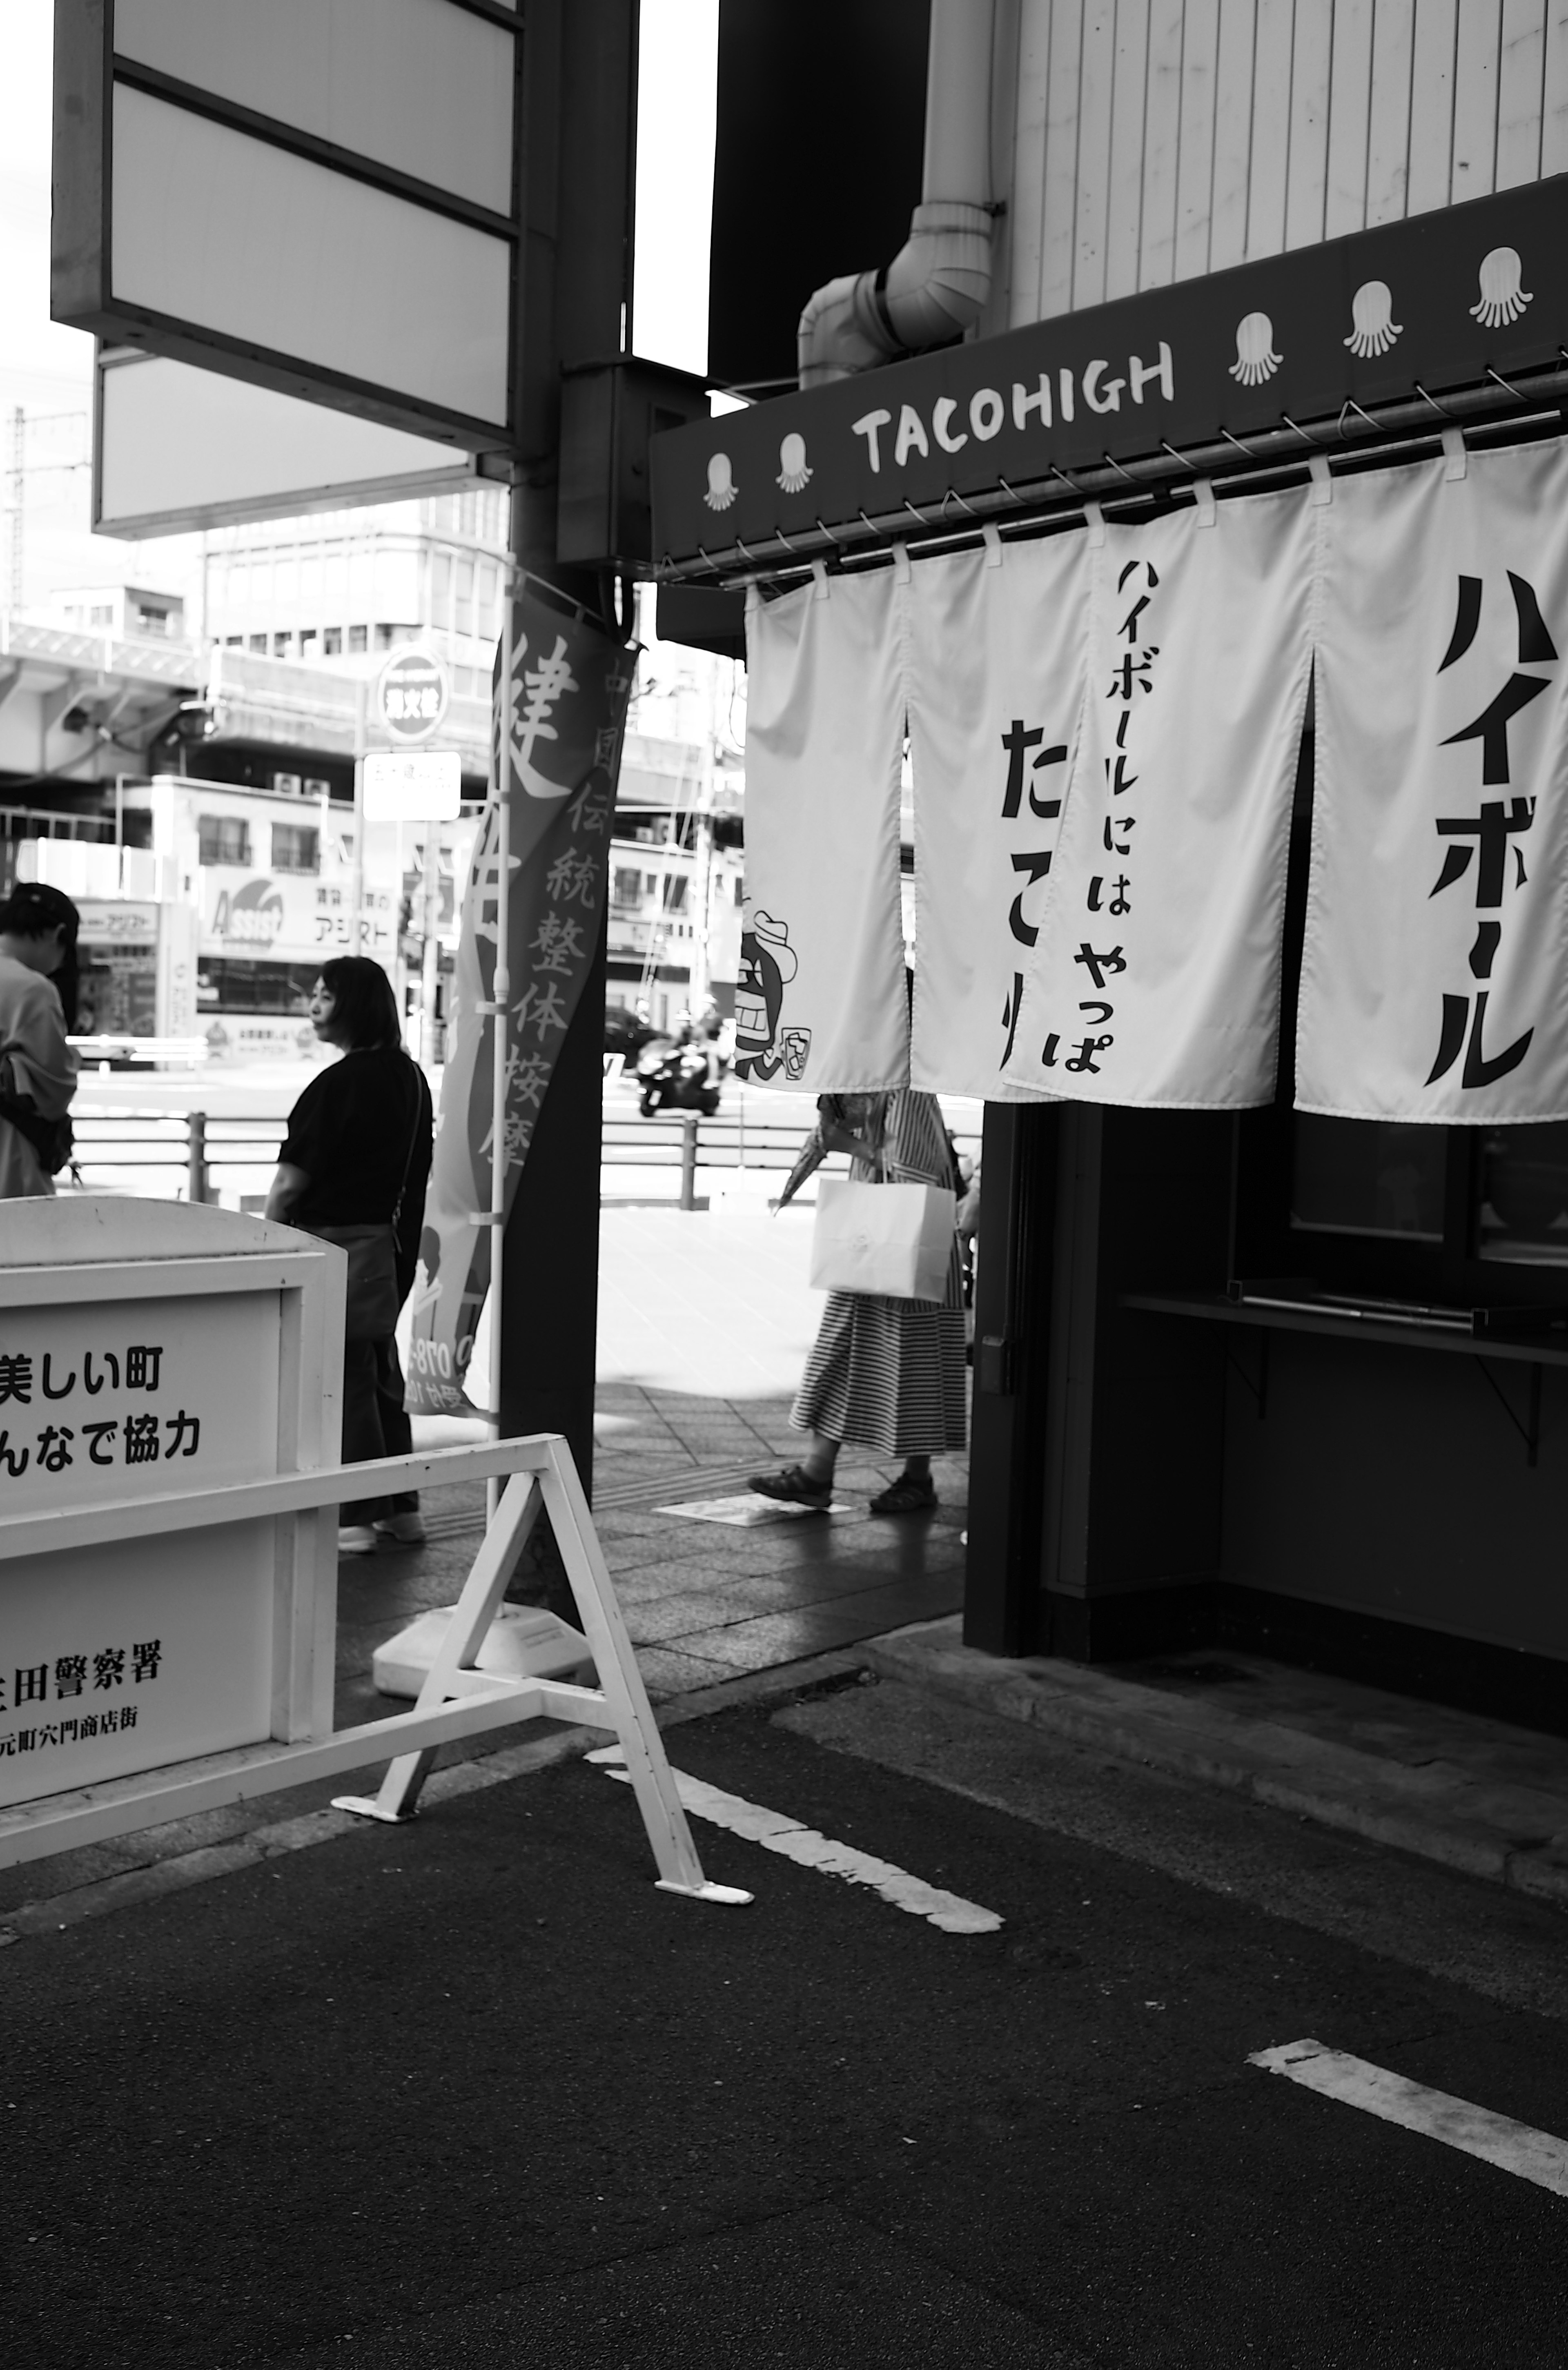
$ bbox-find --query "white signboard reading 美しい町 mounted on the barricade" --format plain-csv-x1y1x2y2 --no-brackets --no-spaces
0,1199,336,1808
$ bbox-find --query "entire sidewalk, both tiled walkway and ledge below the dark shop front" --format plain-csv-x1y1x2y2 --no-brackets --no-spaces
12,1209,1568,1941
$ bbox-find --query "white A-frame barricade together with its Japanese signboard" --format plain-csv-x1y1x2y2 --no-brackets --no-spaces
0,1197,751,1901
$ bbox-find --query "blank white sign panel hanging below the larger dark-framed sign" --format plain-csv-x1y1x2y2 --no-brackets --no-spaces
92,351,474,538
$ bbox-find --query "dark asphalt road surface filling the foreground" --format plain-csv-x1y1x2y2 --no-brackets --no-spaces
0,1687,1568,2370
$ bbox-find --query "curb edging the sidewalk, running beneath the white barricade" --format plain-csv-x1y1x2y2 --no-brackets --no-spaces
0,1647,864,1951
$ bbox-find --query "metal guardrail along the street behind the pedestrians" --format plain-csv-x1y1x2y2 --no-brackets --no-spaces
74,1107,980,1209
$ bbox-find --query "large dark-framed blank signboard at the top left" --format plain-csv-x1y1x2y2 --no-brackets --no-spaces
50,0,523,448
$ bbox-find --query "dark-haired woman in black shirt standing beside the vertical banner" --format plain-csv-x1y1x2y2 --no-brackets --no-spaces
267,955,431,1555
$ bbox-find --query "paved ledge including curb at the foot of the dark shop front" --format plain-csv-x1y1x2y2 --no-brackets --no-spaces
862,1616,1568,1908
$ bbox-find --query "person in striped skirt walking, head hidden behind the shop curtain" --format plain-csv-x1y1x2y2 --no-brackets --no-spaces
751,1088,967,1515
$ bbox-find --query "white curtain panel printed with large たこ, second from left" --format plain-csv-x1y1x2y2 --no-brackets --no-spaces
905,533,1089,1100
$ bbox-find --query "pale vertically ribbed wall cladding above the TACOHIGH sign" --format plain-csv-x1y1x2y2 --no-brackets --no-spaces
1009,0,1568,322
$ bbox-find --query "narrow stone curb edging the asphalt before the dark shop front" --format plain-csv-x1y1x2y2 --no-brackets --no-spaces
860,1619,1568,1908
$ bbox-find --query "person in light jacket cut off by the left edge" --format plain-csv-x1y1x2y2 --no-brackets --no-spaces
0,882,80,1202
